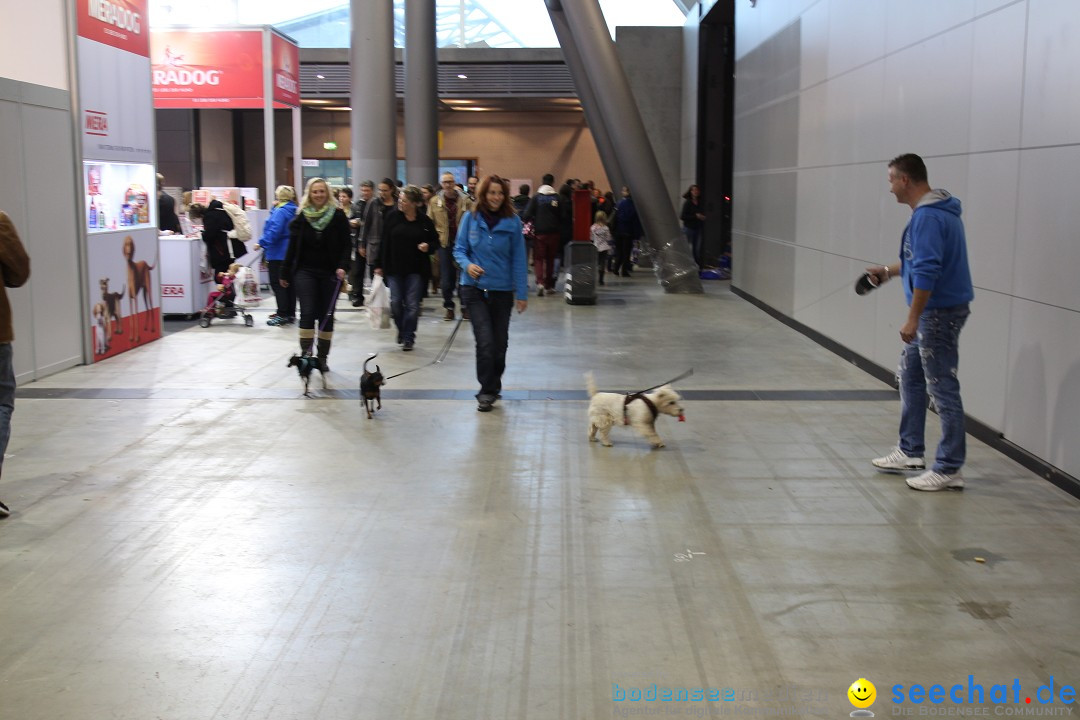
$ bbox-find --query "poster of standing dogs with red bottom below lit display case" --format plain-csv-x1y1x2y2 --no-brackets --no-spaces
86,228,161,363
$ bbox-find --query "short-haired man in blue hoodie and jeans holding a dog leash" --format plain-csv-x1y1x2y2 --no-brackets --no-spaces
866,153,975,491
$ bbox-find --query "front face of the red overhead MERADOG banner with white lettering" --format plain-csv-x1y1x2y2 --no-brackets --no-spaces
150,29,264,109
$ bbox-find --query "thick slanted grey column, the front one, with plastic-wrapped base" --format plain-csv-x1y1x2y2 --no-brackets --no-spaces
548,0,702,293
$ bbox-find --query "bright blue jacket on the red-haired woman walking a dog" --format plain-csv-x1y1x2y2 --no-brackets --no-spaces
454,210,529,300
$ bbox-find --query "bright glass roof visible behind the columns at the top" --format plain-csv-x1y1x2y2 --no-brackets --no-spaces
150,0,686,47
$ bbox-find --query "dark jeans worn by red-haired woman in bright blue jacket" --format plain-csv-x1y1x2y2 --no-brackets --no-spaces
461,285,514,402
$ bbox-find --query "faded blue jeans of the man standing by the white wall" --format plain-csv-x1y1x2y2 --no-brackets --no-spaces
897,304,971,475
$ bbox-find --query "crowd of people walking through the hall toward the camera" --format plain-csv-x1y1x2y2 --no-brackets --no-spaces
187,173,665,412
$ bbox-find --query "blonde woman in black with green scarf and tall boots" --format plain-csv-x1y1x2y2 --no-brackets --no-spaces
280,177,351,372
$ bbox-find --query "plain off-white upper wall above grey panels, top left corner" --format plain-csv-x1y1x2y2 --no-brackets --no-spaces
0,0,69,90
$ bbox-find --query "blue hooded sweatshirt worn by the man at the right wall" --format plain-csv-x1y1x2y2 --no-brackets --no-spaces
900,190,975,309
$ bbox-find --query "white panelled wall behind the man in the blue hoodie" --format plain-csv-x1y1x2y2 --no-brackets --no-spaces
733,0,1080,483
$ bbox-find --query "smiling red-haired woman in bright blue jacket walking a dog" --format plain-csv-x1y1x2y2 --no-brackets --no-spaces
454,175,529,412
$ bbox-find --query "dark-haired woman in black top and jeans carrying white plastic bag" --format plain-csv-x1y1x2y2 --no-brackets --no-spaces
375,185,438,352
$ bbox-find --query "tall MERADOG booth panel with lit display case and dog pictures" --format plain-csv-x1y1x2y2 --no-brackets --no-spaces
76,0,161,362
